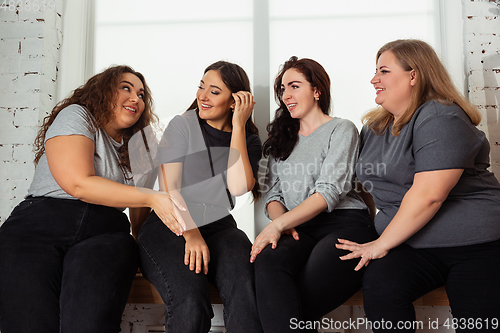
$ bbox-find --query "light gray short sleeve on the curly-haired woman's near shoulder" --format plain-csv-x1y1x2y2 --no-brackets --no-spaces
45,104,95,142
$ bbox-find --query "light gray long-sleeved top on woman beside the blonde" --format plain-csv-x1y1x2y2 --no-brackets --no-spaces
262,117,367,217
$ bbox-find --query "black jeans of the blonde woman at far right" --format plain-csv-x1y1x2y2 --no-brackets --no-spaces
363,240,500,332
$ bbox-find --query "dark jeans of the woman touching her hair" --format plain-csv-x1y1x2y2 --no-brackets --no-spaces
138,212,262,333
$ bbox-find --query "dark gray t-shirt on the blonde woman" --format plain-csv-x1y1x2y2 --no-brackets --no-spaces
356,101,500,248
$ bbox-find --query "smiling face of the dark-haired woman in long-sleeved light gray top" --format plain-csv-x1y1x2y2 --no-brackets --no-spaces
281,68,321,119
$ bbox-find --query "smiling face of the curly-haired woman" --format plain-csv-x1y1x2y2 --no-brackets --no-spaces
104,73,145,142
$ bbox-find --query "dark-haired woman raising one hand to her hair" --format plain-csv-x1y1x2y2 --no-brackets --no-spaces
138,61,262,333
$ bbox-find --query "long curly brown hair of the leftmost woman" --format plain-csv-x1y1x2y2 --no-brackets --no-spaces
33,65,158,172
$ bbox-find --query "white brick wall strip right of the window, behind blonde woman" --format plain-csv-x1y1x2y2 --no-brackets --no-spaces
462,0,500,179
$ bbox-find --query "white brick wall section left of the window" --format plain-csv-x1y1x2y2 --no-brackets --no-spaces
0,0,64,224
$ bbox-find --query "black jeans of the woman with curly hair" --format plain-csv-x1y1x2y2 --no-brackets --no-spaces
0,197,138,333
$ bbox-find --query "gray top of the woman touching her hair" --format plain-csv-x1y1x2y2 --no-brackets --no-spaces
156,110,262,209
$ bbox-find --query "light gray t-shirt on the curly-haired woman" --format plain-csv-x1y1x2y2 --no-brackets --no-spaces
28,104,133,199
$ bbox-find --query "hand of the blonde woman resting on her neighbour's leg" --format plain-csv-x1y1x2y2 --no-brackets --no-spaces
335,239,389,271
